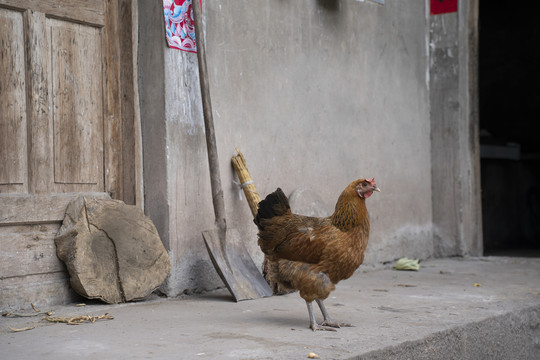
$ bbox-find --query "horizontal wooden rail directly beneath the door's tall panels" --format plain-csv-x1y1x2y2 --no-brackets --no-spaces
0,193,109,227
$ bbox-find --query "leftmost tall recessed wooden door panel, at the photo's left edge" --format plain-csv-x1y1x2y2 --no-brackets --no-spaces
0,9,28,193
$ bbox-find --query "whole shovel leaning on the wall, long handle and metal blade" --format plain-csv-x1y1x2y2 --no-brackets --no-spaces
193,0,272,301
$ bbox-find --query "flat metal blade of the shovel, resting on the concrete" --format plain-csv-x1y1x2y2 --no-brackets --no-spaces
202,229,272,301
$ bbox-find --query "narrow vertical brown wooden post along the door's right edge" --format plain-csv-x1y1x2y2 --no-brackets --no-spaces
103,1,124,199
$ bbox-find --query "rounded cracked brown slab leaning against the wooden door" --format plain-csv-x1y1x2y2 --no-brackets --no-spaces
55,196,171,303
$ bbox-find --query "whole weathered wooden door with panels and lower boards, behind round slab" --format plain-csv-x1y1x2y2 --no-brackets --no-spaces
0,0,136,308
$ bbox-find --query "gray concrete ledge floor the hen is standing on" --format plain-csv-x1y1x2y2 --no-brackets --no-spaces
0,258,540,359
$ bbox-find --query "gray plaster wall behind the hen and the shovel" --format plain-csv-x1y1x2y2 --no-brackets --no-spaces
139,0,460,296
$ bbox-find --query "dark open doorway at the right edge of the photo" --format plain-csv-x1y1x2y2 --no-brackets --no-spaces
479,1,540,256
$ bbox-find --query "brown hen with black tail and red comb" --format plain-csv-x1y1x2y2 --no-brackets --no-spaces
254,179,380,331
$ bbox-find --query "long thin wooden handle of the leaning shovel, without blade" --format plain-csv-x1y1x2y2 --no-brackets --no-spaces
192,0,226,230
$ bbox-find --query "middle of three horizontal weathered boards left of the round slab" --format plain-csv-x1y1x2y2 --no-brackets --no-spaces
0,223,65,279
